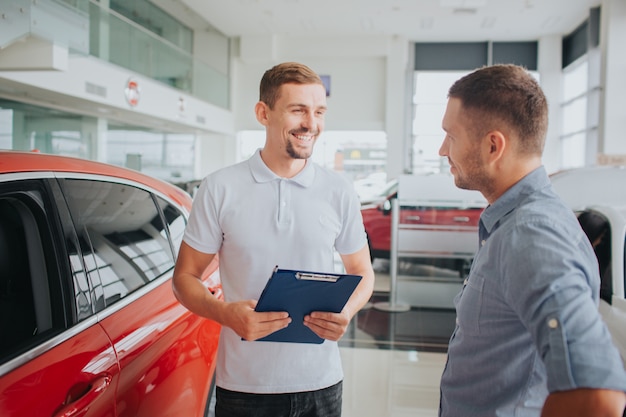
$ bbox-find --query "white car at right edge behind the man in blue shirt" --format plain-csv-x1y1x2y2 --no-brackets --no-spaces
551,166,626,364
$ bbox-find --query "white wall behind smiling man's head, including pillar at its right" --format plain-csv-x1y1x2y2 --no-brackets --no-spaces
233,35,408,178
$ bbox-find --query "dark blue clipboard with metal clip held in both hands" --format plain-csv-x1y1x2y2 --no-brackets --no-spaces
255,267,363,344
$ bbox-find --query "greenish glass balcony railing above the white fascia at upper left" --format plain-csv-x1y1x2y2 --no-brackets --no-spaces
7,0,230,109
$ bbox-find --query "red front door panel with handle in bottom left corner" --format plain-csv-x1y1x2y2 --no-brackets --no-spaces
0,324,119,417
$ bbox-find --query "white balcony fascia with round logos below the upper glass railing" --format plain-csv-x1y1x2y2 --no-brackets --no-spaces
0,55,234,134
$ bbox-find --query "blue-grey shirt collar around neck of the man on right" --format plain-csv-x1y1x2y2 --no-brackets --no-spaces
480,166,550,233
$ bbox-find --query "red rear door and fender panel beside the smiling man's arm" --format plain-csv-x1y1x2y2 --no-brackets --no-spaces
102,281,219,417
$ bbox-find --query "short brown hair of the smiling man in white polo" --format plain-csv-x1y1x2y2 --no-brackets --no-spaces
259,62,324,109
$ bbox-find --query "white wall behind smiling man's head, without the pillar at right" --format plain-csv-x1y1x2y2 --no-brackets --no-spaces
233,36,386,130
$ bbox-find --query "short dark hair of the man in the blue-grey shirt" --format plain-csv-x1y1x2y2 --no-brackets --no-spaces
448,64,548,154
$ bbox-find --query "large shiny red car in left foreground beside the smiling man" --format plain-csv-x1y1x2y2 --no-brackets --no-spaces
0,151,221,417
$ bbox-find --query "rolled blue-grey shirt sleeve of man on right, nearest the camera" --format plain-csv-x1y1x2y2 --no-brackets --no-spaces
503,217,626,392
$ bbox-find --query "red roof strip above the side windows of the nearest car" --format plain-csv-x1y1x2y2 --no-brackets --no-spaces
0,150,191,209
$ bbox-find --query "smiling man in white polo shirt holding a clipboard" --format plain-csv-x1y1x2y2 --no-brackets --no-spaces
173,62,374,417
